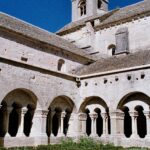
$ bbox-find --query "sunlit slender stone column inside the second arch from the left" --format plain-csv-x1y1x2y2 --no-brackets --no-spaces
58,111,66,137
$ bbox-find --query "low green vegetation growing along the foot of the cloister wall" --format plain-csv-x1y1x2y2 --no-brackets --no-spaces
0,138,150,150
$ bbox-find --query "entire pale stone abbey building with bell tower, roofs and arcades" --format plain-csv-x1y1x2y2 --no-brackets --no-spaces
0,0,150,147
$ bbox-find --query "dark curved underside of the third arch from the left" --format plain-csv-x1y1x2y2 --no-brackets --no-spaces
78,96,108,112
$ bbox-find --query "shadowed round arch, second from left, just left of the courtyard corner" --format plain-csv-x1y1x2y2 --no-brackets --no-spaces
47,95,76,136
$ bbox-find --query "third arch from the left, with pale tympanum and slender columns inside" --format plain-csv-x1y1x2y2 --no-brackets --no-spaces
79,96,110,137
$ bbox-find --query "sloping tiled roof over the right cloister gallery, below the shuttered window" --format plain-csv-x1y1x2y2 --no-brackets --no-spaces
76,50,150,75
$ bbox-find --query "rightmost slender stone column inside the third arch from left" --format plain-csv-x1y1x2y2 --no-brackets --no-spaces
101,113,108,137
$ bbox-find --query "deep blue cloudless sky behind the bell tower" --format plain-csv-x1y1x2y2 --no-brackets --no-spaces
0,0,142,32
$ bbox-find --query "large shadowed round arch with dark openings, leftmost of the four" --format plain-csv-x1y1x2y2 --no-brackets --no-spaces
0,88,38,137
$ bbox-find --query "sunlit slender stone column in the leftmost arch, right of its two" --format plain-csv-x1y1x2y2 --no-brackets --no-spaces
17,108,27,137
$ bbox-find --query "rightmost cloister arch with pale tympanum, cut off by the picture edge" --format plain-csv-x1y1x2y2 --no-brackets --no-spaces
118,92,150,138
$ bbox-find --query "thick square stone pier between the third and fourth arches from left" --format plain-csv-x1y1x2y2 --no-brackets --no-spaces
110,110,124,137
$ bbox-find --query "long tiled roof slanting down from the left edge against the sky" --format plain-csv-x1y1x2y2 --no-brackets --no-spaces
0,13,93,64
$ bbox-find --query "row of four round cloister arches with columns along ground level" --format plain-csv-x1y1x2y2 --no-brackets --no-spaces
0,89,150,146
